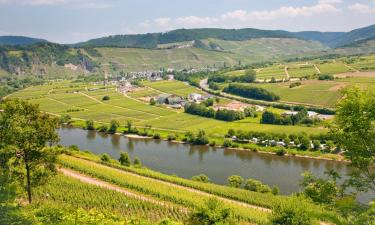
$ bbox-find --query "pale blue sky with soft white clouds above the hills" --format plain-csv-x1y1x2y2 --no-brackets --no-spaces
0,0,375,43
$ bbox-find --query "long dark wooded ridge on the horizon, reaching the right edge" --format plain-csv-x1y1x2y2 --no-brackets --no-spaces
74,25,375,49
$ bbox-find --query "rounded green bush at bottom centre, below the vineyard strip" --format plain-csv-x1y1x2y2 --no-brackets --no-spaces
188,198,236,225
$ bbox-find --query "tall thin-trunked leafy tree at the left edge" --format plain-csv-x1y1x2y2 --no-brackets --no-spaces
0,99,59,203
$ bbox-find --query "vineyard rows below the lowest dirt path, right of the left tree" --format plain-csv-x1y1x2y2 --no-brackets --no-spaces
34,175,187,222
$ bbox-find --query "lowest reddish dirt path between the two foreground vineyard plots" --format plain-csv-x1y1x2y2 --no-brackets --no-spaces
58,168,189,213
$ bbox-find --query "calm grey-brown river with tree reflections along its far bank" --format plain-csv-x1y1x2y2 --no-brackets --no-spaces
58,128,372,202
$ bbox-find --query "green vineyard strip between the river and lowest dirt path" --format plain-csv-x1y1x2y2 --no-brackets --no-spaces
60,153,346,224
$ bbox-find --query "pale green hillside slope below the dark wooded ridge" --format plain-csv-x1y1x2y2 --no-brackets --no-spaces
97,38,326,71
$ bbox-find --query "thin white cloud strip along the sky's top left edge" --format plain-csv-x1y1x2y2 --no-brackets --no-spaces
0,0,112,9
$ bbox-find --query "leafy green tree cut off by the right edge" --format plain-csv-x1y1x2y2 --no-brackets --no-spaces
331,87,375,191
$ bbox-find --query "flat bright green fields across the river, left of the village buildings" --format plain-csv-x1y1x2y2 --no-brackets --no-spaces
9,81,326,139
